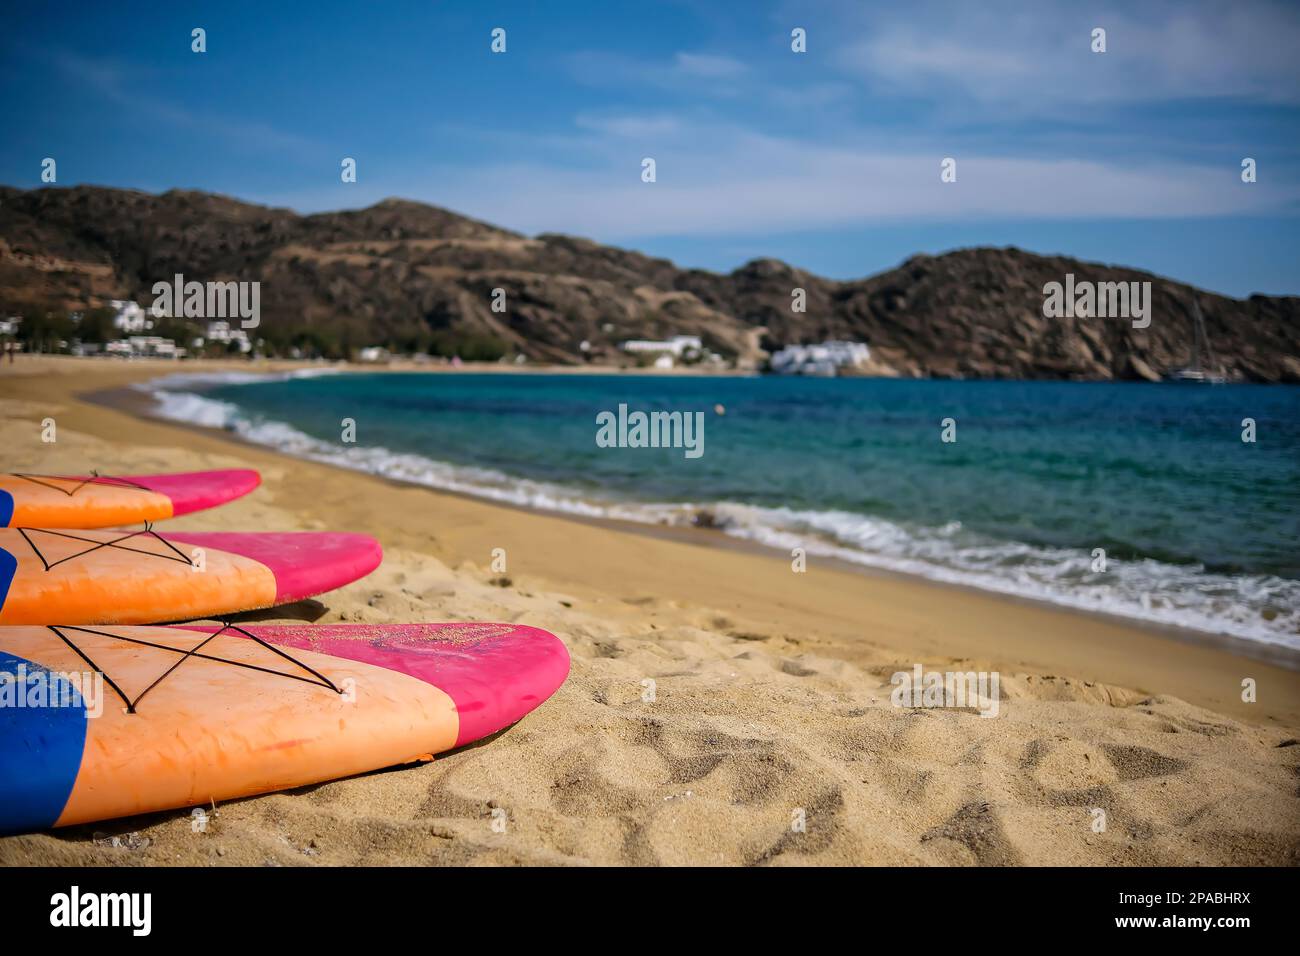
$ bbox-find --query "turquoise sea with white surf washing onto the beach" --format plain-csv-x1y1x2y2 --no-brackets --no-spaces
148,373,1300,649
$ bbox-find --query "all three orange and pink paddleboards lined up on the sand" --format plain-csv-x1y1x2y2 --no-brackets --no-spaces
0,471,569,832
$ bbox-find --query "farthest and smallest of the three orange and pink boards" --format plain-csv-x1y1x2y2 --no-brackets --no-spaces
0,468,261,528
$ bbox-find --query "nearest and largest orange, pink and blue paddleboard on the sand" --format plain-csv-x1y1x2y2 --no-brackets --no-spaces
0,623,569,832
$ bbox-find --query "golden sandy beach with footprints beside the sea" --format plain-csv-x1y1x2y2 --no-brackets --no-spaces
0,356,1300,866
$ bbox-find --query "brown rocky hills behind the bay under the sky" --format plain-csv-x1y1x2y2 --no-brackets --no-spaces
0,186,1300,382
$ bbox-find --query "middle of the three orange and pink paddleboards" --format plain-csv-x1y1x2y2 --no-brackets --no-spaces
0,528,384,624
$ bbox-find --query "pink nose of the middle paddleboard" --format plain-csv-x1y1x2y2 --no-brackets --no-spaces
164,531,384,604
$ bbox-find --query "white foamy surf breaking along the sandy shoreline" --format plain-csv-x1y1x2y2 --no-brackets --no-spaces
142,376,1300,650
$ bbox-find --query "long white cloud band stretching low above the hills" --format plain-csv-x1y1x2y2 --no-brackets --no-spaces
340,117,1300,241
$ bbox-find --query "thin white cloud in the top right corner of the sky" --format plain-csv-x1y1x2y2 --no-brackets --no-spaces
835,0,1300,105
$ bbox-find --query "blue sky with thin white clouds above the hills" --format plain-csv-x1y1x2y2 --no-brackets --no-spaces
0,0,1300,295
